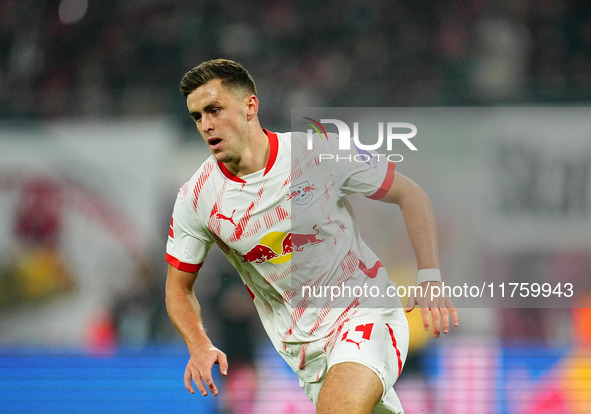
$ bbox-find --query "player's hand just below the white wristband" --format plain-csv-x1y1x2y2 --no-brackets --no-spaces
406,282,459,338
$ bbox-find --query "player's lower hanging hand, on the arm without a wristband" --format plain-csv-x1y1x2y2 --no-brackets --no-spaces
185,344,228,397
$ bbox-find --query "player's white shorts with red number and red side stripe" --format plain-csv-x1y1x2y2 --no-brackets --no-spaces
296,308,409,414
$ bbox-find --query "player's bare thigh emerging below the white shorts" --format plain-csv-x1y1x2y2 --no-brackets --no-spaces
316,362,383,414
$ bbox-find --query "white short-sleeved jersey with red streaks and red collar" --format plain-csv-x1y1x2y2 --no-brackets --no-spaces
166,131,400,378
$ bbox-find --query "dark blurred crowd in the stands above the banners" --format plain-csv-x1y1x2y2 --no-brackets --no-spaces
0,0,591,127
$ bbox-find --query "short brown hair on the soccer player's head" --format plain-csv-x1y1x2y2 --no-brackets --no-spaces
179,59,257,97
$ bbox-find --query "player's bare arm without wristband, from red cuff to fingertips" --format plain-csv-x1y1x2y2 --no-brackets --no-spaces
166,264,228,396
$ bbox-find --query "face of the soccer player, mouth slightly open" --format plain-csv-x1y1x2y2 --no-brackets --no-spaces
187,79,252,163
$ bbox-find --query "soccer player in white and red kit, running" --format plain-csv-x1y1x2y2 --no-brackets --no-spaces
166,59,458,414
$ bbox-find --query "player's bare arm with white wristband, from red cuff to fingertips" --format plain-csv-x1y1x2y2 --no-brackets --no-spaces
379,173,458,338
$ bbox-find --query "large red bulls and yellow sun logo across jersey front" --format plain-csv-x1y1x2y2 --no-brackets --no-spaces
241,225,324,264
